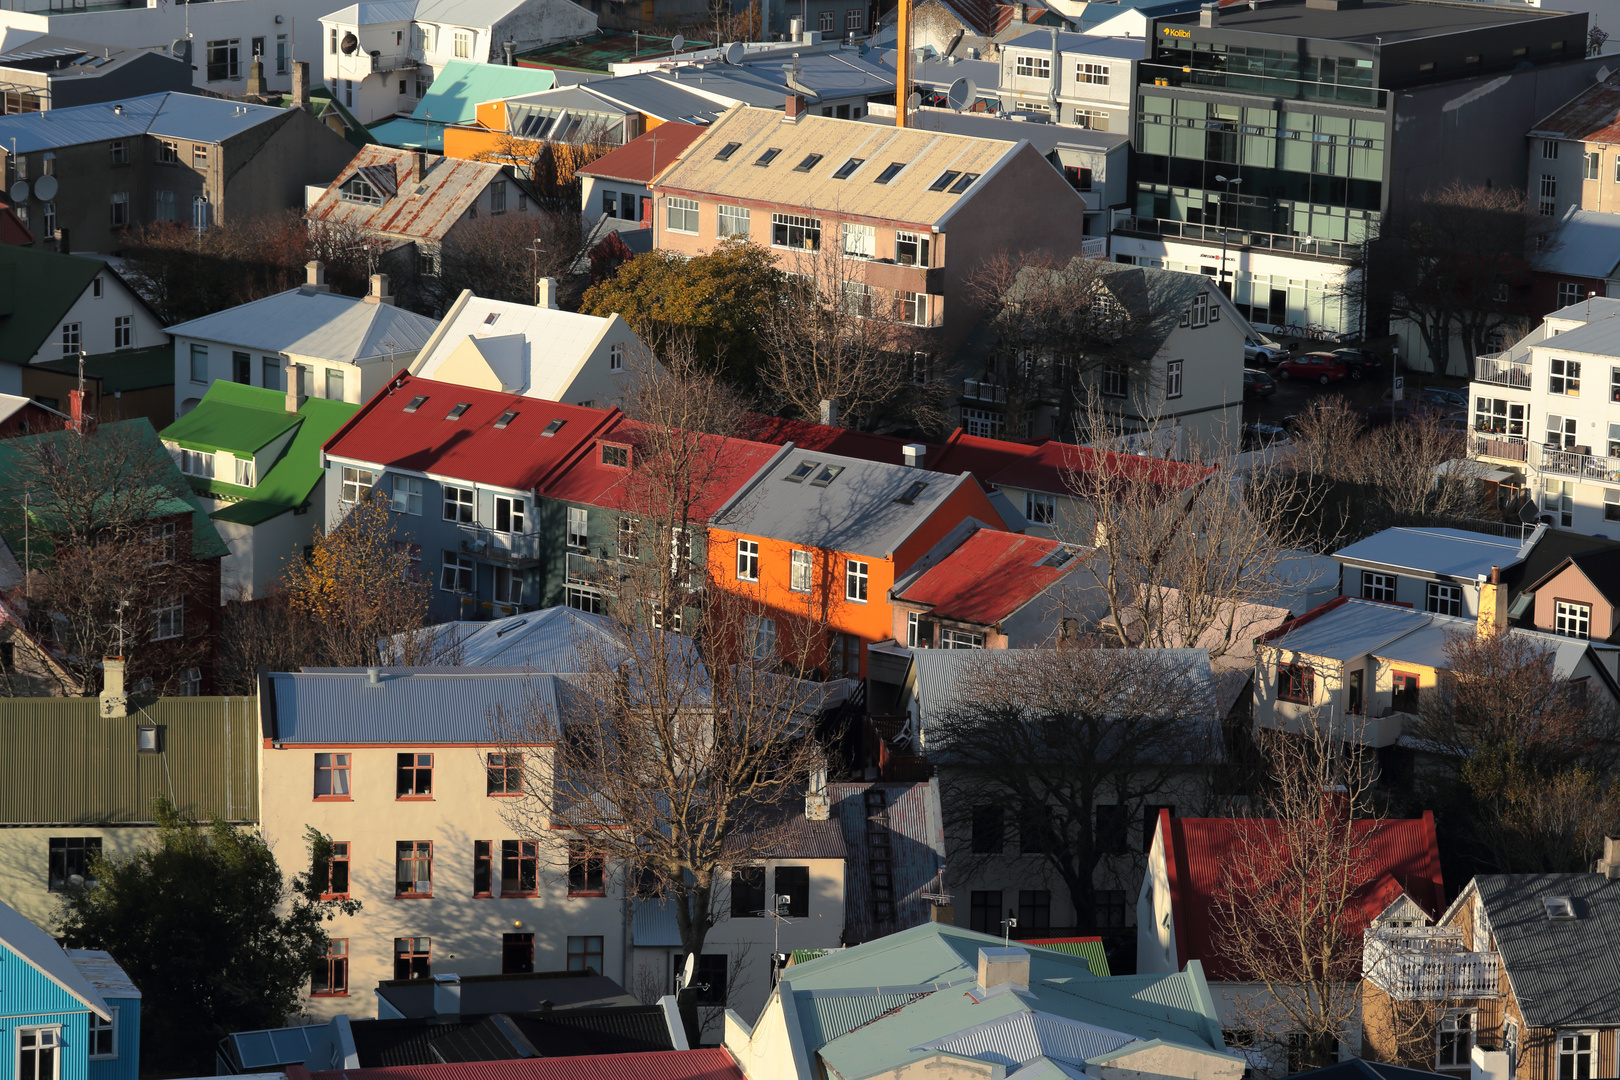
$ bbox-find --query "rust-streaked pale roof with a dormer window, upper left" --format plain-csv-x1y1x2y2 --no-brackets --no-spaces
305,146,509,240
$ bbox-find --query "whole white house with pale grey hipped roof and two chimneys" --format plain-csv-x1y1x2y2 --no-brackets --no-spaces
168,262,437,416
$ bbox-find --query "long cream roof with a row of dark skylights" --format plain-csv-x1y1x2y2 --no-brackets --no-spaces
653,105,1025,225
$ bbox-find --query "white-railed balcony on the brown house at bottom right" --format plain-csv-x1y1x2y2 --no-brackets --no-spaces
1361,926,1502,1001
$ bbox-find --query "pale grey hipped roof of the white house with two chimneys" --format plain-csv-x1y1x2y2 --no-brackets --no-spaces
168,288,439,363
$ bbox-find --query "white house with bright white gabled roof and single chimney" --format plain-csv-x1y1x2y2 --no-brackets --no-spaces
410,279,646,408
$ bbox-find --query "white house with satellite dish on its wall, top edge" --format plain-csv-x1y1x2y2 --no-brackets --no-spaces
321,0,596,123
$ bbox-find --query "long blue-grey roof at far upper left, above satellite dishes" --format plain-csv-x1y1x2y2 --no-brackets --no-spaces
0,92,287,154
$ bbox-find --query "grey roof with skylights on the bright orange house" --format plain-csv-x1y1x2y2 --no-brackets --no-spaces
714,444,974,559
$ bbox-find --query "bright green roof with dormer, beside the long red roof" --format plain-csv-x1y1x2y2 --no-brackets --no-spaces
162,381,360,525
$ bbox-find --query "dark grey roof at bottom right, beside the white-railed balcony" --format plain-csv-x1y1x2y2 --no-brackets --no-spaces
1483,874,1620,1028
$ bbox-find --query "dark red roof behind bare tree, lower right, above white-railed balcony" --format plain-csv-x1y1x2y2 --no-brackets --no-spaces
1158,810,1445,980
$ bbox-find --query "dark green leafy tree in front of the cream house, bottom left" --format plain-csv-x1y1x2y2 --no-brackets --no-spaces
60,797,360,1075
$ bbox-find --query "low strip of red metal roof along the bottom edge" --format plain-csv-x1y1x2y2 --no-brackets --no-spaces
298,1049,745,1080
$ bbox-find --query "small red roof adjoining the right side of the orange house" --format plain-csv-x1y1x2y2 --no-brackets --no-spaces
896,529,1077,627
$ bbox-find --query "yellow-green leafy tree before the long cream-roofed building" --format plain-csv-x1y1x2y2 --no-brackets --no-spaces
580,240,782,383
